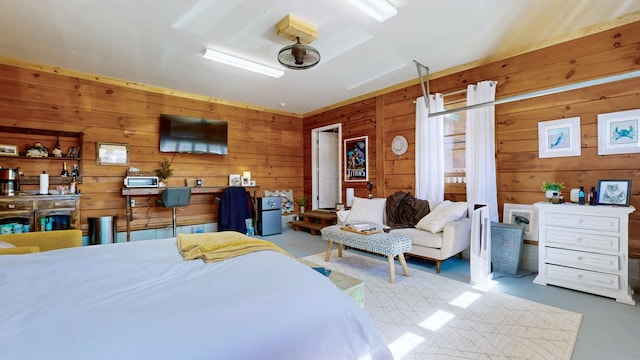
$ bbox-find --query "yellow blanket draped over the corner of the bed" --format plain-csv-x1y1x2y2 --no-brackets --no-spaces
178,231,291,262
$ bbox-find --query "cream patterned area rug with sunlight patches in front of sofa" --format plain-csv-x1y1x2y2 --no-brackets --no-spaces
305,250,582,360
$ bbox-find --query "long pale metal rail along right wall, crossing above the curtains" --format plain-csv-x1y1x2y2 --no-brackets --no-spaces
424,71,640,117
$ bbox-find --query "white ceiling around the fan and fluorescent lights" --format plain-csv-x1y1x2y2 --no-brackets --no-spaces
0,0,640,113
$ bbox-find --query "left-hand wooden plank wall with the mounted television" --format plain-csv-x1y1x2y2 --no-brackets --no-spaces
0,65,303,233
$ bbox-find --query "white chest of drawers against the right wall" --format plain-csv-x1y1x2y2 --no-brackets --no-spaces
533,202,636,305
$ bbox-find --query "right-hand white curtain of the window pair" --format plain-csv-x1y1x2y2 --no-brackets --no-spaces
466,81,498,222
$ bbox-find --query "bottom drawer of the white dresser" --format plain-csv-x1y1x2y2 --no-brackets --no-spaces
541,264,620,291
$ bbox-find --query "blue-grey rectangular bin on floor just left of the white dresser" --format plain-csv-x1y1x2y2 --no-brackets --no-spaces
491,223,524,275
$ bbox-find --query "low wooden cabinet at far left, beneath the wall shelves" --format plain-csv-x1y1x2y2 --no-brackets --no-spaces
0,194,80,232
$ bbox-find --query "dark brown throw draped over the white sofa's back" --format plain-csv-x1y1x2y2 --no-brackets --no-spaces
386,191,430,230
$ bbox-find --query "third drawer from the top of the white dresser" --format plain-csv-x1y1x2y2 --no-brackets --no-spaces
544,247,620,273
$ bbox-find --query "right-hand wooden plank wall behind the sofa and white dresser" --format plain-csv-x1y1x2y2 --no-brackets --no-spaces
304,22,640,257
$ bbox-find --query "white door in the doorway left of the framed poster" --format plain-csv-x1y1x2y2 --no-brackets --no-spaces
318,131,340,209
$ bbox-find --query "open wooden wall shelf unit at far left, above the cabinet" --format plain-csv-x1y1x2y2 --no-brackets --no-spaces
0,126,83,186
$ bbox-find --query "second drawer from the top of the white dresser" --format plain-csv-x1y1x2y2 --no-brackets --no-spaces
543,227,620,253
